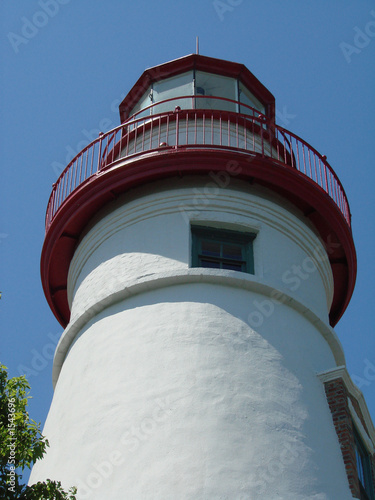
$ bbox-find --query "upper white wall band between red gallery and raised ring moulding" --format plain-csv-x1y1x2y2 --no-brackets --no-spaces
68,181,333,322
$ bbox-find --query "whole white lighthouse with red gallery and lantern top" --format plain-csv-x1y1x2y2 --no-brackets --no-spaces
30,54,375,500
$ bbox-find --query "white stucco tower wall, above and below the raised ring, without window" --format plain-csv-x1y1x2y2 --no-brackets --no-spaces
31,185,351,500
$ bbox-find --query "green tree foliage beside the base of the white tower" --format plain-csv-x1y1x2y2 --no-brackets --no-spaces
0,364,76,500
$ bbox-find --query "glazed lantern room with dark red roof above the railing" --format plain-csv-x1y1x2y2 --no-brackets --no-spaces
120,54,275,122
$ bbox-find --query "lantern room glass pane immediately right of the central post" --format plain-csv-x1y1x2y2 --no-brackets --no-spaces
195,71,237,111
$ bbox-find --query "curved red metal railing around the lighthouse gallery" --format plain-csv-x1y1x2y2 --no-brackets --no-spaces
46,96,350,230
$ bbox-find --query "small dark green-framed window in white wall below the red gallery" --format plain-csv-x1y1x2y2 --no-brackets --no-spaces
191,226,255,274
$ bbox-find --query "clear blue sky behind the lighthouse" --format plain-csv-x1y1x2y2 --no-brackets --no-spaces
0,0,375,484
